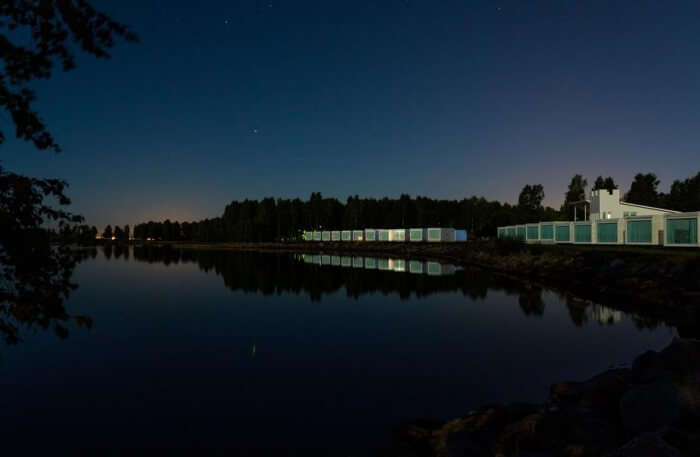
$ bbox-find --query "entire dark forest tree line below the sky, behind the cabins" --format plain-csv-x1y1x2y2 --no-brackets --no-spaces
112,172,700,242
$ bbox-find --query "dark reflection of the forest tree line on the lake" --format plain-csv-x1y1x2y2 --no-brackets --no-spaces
126,246,662,329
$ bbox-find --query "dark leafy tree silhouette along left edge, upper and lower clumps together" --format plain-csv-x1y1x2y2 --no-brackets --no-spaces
0,0,136,343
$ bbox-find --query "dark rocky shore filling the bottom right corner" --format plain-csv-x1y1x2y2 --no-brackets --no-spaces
390,339,700,457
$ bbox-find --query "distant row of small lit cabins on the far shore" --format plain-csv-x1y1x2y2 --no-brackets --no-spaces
304,227,467,242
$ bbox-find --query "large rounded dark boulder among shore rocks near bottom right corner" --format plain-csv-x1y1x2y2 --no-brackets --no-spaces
620,378,681,433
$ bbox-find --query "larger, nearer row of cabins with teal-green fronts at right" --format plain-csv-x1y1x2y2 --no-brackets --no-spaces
498,212,700,247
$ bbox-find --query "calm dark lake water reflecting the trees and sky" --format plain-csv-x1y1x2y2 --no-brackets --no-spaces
0,244,676,455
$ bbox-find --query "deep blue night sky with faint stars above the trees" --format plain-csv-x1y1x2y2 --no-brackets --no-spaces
0,0,700,227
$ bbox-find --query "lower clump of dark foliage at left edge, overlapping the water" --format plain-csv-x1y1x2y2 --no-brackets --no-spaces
0,168,97,345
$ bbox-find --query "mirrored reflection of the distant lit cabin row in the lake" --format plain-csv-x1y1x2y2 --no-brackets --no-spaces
297,254,457,276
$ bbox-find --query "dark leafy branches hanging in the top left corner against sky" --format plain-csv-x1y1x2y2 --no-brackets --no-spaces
0,0,137,151
